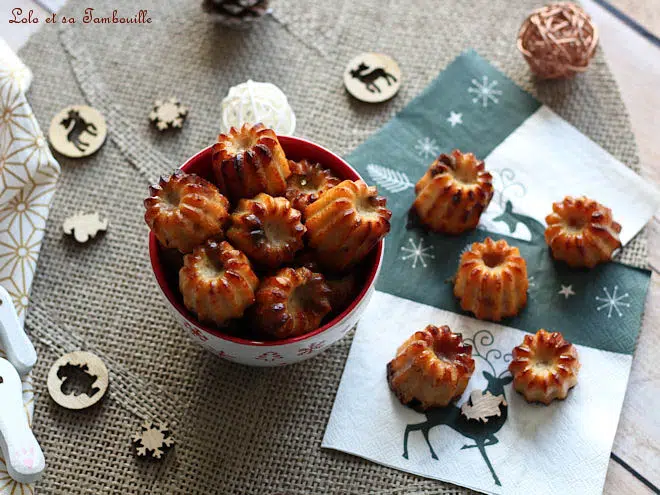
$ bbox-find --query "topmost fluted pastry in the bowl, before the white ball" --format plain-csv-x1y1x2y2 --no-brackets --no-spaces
213,124,291,201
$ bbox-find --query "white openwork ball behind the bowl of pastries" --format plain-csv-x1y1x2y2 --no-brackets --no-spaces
222,80,296,136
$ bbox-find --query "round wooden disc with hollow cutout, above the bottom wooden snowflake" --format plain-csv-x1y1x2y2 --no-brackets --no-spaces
48,351,109,409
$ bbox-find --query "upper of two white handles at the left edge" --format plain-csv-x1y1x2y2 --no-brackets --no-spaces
0,286,37,376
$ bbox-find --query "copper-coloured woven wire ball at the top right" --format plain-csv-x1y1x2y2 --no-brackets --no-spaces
518,3,598,79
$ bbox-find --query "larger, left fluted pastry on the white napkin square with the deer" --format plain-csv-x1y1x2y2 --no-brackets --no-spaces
387,325,474,410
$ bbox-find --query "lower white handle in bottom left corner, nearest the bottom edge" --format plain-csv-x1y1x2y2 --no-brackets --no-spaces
0,358,46,483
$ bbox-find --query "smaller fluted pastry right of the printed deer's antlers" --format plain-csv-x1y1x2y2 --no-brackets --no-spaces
509,329,580,405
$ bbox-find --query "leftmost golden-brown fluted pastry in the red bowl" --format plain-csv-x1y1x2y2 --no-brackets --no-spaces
144,170,229,253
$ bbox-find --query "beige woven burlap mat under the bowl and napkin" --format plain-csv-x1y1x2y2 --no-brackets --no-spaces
20,0,646,494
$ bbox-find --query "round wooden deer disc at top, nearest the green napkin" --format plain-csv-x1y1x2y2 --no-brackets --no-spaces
344,53,401,103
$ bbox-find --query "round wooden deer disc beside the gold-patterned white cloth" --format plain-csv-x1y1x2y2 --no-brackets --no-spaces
48,105,108,158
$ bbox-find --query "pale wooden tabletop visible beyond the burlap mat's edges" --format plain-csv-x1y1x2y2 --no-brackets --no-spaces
0,0,660,495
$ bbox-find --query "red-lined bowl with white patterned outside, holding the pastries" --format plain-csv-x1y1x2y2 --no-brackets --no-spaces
149,136,384,366
